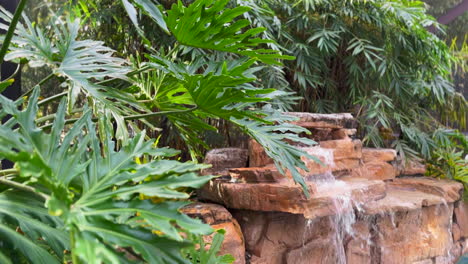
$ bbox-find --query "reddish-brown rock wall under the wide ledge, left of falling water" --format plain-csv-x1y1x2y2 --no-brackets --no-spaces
233,210,345,264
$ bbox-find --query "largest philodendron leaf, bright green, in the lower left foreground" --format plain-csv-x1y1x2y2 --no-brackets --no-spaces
0,89,213,263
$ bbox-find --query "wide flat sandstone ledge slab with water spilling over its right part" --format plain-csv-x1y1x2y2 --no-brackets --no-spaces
200,179,385,219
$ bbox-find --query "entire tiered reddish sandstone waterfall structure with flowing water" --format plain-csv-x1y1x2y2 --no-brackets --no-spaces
194,113,468,264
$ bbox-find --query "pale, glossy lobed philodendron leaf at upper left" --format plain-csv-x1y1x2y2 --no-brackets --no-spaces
0,9,148,142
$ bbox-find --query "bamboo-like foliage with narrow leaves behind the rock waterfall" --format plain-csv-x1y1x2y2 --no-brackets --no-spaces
234,0,467,163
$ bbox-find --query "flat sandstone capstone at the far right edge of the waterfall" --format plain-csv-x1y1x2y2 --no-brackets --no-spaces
388,177,463,203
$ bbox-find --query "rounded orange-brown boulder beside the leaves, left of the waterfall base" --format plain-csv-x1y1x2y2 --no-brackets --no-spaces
181,203,245,264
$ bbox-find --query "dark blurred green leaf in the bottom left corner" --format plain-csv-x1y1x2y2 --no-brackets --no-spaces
0,190,66,263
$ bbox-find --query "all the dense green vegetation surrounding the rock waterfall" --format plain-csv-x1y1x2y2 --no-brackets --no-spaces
0,0,468,263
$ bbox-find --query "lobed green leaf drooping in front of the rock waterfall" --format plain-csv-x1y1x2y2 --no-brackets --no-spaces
135,56,318,193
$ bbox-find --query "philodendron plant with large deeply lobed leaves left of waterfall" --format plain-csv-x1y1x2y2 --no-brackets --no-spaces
0,0,313,264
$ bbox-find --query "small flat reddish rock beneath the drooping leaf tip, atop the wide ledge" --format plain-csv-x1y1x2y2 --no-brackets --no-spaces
229,166,292,183
